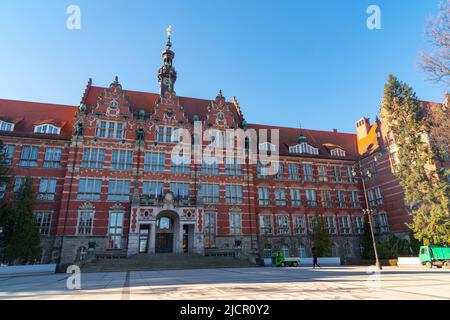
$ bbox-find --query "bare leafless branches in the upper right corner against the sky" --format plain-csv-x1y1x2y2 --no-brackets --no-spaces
419,0,450,84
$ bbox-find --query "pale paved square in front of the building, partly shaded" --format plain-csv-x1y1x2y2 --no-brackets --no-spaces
0,267,450,300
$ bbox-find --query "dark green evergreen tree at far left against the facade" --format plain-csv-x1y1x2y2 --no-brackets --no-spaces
2,178,41,264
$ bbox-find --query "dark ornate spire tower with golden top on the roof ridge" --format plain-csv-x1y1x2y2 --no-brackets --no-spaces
158,26,177,96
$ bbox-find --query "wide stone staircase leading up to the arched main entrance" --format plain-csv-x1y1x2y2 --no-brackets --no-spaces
81,254,256,272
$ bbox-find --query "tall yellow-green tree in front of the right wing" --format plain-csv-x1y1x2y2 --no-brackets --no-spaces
382,75,450,244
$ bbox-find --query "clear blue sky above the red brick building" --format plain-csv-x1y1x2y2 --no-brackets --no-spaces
0,0,446,132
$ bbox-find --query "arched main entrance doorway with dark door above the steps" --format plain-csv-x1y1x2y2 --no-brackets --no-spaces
155,211,179,253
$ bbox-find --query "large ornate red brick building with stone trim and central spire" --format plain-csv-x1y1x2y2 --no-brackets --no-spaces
0,38,446,263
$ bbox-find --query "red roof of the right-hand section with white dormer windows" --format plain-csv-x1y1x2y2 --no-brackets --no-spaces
248,124,358,160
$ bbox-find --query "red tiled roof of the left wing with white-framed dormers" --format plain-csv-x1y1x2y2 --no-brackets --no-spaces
0,99,78,139
